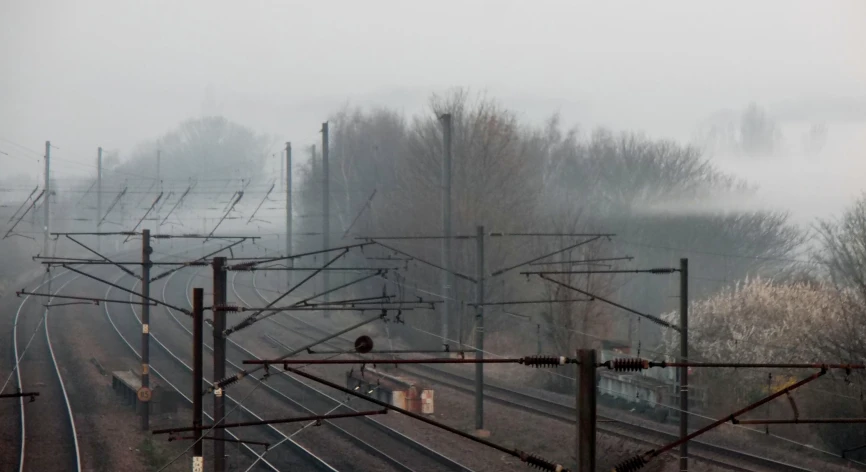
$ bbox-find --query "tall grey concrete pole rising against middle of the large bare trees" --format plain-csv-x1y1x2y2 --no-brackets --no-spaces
440,113,455,346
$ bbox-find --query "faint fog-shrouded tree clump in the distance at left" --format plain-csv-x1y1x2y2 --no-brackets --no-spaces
55,116,275,236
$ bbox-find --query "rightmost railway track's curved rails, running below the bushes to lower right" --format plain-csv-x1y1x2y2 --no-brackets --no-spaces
240,271,812,472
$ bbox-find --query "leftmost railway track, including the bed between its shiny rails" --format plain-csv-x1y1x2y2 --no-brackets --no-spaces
12,271,81,472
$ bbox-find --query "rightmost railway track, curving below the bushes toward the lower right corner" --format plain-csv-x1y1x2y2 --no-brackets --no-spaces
231,262,817,472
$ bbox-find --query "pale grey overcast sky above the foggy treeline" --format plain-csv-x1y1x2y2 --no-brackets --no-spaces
0,0,866,218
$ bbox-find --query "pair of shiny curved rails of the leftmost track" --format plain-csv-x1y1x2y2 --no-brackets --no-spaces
12,270,81,472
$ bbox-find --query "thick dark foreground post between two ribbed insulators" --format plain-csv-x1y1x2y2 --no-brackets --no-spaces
577,349,597,472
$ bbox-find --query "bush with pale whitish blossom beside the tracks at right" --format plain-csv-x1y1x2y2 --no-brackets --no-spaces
663,278,866,449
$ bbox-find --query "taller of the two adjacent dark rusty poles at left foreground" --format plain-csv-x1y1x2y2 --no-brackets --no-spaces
211,257,228,472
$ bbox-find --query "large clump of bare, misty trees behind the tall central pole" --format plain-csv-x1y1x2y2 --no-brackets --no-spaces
296,90,802,366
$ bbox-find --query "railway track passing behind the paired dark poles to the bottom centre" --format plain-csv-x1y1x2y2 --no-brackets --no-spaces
163,260,470,471
